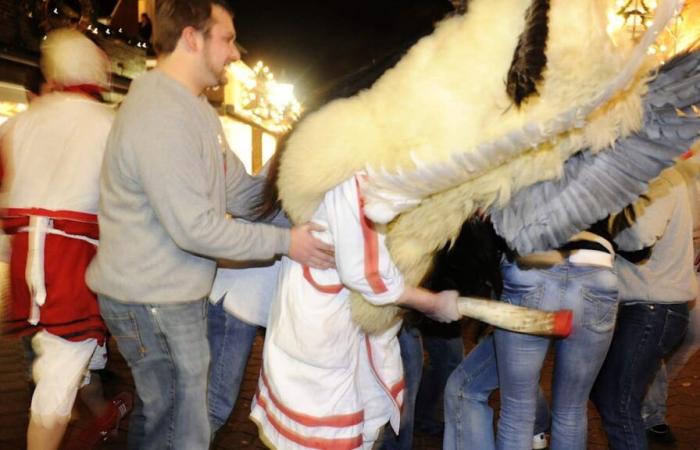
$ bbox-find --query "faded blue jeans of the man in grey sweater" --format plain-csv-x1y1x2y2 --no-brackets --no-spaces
98,295,210,450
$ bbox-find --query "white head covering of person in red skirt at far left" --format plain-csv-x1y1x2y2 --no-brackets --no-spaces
41,28,111,87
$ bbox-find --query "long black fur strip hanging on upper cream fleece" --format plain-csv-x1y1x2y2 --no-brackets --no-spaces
506,0,549,107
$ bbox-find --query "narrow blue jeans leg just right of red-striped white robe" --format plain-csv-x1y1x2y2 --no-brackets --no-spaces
379,324,423,450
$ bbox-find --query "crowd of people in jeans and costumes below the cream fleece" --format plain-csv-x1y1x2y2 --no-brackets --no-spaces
0,0,700,450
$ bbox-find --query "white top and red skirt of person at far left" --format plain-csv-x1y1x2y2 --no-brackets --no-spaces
2,89,114,343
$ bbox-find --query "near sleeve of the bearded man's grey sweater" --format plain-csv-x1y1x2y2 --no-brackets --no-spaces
134,111,289,259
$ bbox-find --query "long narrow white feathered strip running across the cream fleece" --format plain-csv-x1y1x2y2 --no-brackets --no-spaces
363,0,683,223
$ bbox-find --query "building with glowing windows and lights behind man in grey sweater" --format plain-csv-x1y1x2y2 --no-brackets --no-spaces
0,0,300,173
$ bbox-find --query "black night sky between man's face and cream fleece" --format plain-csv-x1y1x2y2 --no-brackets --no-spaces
229,0,452,100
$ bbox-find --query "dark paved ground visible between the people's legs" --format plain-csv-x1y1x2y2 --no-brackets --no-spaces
0,326,700,450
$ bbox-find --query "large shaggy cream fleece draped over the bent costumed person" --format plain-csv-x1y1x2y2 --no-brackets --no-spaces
278,0,697,332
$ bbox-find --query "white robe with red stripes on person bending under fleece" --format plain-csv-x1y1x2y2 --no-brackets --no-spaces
251,176,404,449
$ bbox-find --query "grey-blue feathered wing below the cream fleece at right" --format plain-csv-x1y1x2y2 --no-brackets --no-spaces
491,50,700,254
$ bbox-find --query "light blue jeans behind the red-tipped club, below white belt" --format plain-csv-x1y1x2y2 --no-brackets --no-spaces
494,261,617,450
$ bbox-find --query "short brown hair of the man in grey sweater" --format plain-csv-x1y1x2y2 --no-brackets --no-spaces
153,0,233,55
